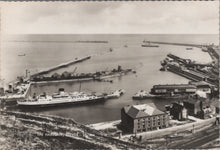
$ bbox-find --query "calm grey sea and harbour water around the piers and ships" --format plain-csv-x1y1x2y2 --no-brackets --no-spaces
1,35,218,124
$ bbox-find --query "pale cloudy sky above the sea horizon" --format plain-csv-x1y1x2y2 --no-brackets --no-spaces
1,1,219,34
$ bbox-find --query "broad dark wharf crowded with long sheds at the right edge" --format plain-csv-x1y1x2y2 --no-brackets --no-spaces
161,54,219,87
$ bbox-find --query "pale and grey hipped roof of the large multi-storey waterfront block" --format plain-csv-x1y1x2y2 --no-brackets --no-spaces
123,103,165,118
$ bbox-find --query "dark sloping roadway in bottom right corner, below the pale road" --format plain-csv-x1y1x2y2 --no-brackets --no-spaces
169,126,219,149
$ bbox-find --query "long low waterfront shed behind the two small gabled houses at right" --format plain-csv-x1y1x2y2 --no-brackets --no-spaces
151,84,196,95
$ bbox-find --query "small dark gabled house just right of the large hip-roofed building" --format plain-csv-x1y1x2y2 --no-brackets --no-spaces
169,102,188,121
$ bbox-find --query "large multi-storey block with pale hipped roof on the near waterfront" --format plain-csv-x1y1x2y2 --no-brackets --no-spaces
121,103,169,133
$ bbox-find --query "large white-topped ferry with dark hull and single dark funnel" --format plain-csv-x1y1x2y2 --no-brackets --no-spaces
17,89,104,107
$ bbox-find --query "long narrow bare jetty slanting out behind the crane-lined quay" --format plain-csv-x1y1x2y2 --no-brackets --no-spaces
31,56,91,77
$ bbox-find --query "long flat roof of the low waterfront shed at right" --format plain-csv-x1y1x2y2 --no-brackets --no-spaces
153,84,196,89
